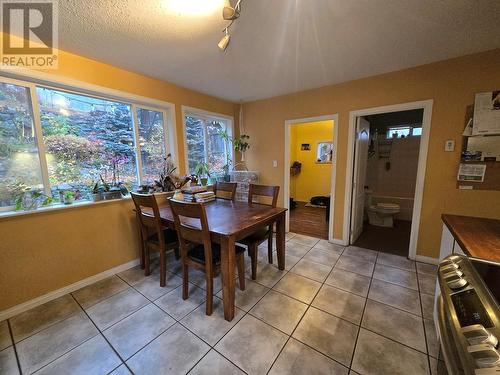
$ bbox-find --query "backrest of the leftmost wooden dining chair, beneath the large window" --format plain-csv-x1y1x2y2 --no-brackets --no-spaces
130,192,165,244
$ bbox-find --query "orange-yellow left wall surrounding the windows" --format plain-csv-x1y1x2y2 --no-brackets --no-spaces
0,34,239,311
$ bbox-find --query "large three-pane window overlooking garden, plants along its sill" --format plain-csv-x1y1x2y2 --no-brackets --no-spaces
0,78,169,209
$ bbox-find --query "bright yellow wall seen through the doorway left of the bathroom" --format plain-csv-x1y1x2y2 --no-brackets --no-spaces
290,120,334,202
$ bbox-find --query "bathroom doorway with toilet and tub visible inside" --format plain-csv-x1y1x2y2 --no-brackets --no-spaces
347,102,432,259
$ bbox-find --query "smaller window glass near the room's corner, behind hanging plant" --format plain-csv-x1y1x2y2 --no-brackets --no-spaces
185,112,231,176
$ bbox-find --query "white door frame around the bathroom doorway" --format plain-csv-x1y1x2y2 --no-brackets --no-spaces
342,99,434,260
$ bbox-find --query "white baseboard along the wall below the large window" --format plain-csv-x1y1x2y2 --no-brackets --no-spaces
0,254,139,322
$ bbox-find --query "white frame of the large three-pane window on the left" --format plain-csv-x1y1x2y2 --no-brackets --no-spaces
0,71,178,213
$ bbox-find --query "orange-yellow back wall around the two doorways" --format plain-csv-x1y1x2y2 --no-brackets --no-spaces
243,49,500,257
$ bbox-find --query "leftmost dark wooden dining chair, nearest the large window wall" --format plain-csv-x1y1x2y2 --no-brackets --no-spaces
130,192,179,287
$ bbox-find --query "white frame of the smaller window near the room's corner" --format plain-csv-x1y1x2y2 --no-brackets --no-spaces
181,105,234,174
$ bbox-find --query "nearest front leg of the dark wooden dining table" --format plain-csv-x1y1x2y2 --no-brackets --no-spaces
220,237,236,322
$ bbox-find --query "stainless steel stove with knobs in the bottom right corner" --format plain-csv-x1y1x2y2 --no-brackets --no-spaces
435,255,500,375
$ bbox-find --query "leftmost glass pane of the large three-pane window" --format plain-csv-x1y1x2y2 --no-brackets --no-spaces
0,83,43,207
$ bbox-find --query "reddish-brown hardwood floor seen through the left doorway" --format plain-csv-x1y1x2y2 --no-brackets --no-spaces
290,202,328,240
